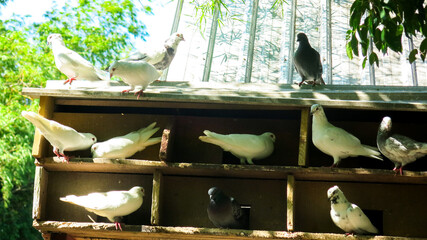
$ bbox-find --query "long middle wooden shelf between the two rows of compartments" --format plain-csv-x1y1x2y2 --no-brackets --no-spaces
39,157,427,184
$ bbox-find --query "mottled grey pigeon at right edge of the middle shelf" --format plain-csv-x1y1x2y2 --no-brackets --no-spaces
377,117,427,175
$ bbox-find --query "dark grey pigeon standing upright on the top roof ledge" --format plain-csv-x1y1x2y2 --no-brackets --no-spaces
294,33,325,86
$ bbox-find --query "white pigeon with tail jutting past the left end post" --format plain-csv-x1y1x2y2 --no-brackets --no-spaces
21,111,96,162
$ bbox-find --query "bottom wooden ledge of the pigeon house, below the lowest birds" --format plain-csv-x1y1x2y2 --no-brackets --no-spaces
33,221,424,240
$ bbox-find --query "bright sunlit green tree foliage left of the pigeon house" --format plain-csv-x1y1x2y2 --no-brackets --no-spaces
0,0,151,239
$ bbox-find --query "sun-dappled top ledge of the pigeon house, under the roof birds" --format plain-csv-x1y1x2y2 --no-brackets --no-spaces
22,80,427,111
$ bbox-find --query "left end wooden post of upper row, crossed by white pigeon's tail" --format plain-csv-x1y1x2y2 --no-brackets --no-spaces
32,96,55,159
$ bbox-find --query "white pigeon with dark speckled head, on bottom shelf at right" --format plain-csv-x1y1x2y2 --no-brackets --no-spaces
328,186,378,235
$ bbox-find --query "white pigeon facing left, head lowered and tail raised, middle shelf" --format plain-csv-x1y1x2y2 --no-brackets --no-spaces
91,122,162,159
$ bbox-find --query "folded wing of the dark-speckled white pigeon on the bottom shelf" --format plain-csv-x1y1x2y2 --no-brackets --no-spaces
347,204,378,233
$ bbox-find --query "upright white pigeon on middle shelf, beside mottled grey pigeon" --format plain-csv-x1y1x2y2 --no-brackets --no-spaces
310,104,383,167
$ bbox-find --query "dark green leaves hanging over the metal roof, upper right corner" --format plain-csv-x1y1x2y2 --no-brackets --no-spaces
346,0,427,67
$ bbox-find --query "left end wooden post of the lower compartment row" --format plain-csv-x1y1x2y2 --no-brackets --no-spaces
33,166,48,219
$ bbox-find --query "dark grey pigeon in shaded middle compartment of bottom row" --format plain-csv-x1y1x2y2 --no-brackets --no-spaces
207,187,249,229
